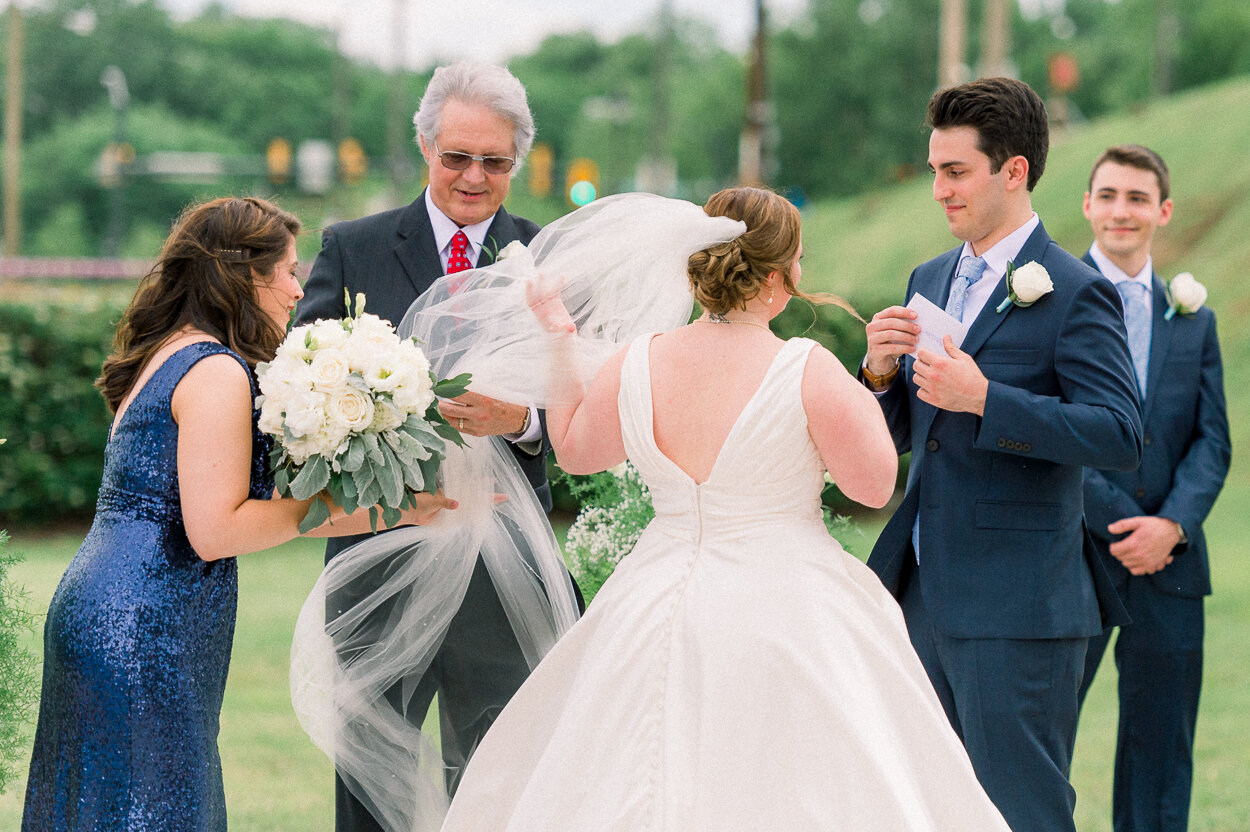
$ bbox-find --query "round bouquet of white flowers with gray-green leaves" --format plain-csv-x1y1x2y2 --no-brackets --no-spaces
256,295,469,533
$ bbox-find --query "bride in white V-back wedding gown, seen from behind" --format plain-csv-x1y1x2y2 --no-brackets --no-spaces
443,189,1008,832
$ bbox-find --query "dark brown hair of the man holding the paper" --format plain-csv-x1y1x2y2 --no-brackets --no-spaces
928,77,1050,191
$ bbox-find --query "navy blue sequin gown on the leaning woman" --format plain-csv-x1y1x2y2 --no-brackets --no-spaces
21,342,273,832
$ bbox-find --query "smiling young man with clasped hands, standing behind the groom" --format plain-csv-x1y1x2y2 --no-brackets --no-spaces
1080,145,1230,832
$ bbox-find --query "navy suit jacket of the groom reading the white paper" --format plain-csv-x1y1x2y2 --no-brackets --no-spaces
869,219,1141,638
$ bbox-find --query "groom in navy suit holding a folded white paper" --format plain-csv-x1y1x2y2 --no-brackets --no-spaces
861,79,1141,832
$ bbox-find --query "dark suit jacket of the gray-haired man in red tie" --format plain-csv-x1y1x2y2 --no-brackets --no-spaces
295,191,551,557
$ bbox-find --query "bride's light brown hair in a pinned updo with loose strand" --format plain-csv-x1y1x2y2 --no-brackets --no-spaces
686,187,864,321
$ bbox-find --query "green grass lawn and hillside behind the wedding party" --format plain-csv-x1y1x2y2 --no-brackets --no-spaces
0,79,1250,832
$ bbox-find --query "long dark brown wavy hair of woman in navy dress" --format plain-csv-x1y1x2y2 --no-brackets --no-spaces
95,196,300,412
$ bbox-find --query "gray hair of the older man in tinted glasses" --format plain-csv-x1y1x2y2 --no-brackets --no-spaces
413,61,534,174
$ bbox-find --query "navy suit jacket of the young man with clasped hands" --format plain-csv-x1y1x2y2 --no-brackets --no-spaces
1085,254,1233,598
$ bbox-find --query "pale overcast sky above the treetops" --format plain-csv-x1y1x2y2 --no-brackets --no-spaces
159,0,806,70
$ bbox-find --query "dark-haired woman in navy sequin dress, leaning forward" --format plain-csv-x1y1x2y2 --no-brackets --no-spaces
23,197,454,832
